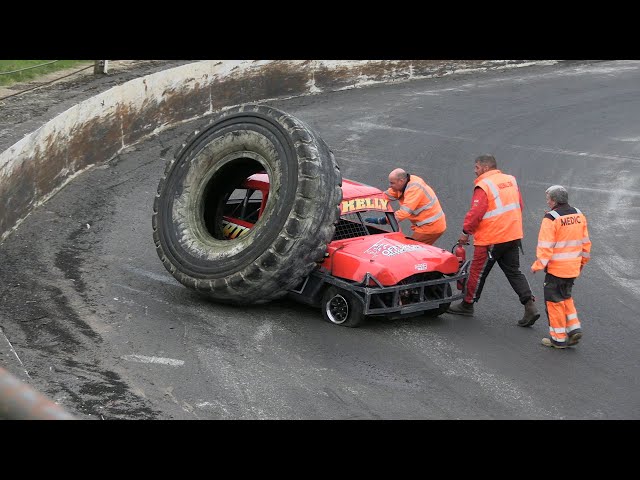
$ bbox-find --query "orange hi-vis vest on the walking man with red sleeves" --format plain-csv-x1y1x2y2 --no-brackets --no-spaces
473,170,524,245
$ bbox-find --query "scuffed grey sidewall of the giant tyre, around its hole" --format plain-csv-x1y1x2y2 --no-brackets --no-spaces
160,118,297,278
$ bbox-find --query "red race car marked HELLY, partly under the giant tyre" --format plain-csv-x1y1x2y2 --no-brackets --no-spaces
222,173,470,327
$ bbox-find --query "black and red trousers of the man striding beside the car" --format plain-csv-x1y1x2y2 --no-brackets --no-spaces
464,240,533,305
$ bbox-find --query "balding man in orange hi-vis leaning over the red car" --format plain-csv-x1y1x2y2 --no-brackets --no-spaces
365,168,447,245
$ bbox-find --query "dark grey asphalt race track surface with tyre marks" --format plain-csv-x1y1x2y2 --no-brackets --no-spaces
0,61,640,420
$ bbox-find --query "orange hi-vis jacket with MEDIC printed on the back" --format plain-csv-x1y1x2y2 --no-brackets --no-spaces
531,205,591,278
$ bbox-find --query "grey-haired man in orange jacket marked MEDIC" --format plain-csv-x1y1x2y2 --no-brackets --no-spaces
531,185,591,348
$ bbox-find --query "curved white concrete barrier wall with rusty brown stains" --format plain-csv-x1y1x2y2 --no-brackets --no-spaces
0,60,552,242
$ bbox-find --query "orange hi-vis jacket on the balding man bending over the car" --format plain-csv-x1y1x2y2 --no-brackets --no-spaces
385,175,447,233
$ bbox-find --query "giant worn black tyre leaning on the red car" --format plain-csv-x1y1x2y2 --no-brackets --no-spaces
152,105,342,305
